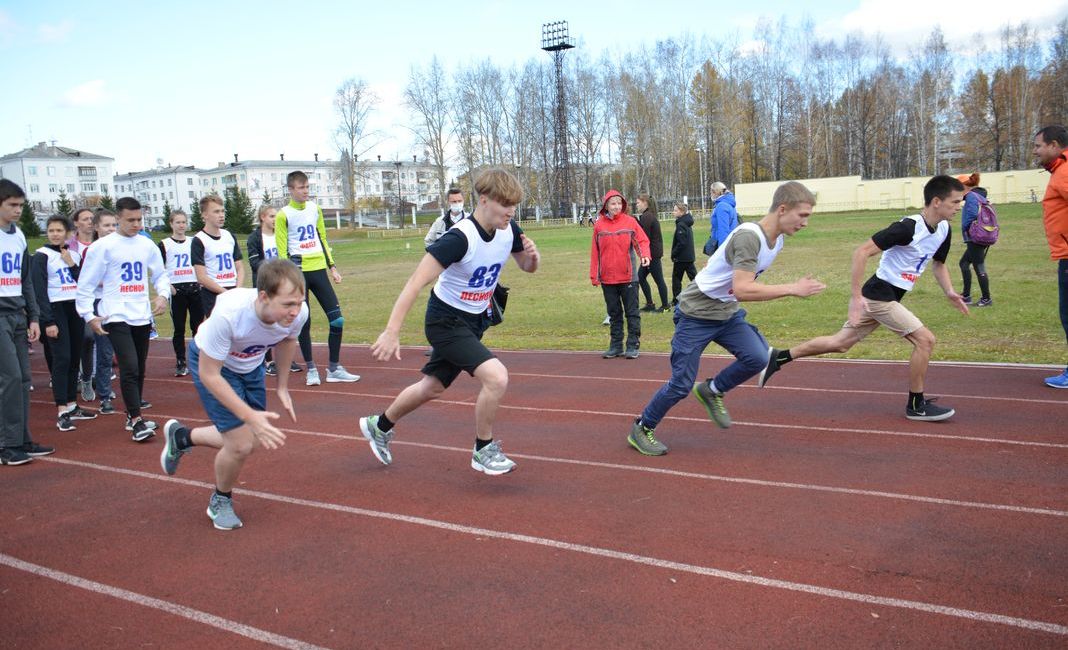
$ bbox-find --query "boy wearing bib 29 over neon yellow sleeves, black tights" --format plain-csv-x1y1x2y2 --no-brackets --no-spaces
274,171,360,386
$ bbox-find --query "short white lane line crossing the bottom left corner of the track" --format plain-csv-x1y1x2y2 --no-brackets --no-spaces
0,553,323,650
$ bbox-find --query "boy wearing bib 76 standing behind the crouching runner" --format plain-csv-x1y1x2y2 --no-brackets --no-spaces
190,194,245,318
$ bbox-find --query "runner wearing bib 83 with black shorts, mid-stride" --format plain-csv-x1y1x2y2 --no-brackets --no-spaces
360,169,540,475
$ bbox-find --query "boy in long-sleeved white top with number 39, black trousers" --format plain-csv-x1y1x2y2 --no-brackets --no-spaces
76,196,171,442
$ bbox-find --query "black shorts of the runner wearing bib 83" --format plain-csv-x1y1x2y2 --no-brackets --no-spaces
422,310,497,389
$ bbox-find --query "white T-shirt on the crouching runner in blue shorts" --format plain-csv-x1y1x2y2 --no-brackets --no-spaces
193,288,309,375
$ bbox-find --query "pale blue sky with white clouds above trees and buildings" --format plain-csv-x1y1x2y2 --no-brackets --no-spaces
0,0,1068,173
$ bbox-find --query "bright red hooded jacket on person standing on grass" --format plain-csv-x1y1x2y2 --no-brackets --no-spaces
590,190,649,286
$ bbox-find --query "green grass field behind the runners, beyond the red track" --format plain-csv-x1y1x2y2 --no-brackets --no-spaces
39,204,1065,363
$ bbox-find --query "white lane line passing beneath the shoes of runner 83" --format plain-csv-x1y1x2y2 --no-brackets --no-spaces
29,403,1068,518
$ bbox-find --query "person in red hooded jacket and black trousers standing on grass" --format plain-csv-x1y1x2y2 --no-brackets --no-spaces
590,190,649,359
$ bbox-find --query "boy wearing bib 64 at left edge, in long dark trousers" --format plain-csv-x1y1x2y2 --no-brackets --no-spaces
0,178,56,465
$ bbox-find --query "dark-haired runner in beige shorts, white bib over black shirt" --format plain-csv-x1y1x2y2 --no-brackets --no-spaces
758,176,968,422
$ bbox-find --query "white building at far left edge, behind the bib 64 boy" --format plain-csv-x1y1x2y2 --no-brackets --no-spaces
0,140,115,216
